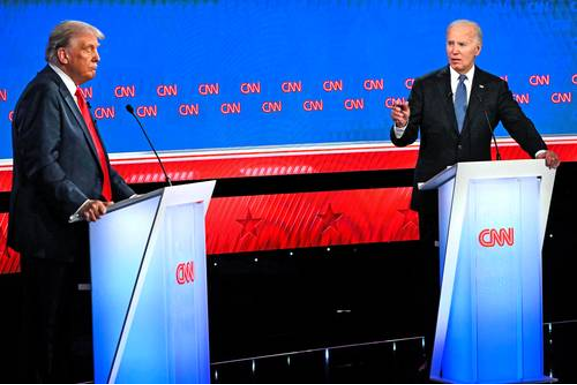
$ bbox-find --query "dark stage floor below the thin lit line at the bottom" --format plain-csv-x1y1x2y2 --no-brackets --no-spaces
212,321,577,384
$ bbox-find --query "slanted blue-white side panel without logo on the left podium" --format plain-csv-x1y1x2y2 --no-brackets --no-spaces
90,196,160,384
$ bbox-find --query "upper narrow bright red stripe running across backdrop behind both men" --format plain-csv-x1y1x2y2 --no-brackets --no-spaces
0,137,577,192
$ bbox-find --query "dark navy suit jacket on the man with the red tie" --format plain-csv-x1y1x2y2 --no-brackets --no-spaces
8,67,134,261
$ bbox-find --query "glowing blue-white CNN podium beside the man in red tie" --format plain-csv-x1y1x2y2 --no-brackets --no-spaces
90,181,216,384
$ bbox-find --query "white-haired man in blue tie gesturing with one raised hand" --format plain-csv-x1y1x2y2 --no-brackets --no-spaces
391,20,559,370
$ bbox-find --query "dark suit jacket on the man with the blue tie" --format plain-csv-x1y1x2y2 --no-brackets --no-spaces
391,66,547,210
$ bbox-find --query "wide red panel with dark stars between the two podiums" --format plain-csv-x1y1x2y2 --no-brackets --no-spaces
207,188,419,254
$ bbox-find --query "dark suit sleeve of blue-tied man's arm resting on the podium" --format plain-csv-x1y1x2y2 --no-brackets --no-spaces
497,81,547,158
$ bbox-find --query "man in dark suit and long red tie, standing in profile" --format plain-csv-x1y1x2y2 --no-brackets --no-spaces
8,21,134,383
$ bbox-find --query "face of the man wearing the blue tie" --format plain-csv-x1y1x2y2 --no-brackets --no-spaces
447,24,481,74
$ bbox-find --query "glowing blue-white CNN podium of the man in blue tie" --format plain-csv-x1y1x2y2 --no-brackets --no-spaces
419,160,555,383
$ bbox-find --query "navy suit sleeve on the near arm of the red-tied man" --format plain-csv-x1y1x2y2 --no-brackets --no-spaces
14,84,88,218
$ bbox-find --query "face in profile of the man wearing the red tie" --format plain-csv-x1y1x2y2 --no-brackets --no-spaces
58,33,100,85
